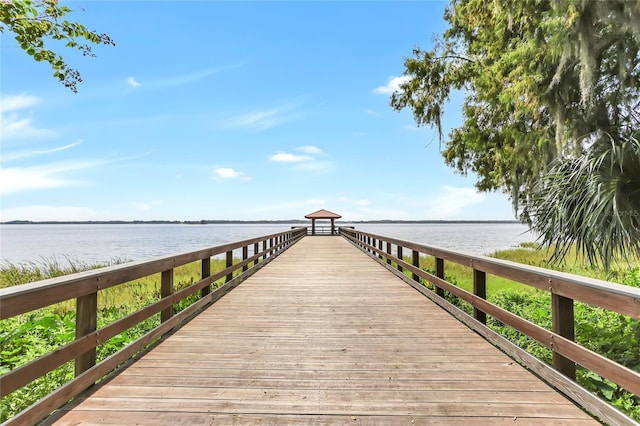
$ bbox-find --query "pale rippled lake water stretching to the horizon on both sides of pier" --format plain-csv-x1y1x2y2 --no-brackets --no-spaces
0,223,535,264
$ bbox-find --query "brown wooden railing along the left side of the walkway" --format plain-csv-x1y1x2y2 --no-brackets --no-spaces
0,227,307,424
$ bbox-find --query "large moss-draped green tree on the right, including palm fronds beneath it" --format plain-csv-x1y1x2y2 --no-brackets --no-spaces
391,0,640,267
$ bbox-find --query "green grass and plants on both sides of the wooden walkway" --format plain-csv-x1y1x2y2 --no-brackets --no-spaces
0,250,640,421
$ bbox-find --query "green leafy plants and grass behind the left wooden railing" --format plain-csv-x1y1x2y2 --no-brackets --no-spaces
0,258,230,422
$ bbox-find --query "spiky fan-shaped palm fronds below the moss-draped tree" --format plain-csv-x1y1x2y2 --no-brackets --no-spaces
529,131,640,269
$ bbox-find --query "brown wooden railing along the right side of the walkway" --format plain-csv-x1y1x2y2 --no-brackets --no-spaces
339,227,640,424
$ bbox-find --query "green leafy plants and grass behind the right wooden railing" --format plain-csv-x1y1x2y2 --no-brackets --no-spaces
405,243,640,420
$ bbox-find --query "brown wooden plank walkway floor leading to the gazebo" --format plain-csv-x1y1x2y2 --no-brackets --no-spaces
51,237,598,425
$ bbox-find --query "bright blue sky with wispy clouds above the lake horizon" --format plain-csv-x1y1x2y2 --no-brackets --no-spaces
0,1,514,221
